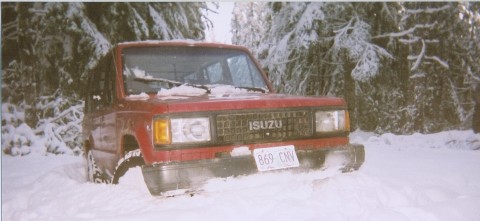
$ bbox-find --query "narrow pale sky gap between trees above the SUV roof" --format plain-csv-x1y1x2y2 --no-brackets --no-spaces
206,1,235,44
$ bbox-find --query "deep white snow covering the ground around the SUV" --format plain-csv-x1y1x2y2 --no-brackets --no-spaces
2,131,480,221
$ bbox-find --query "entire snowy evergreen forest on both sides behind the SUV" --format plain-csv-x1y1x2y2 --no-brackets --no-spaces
1,2,480,155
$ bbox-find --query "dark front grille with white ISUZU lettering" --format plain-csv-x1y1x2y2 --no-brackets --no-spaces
216,110,313,143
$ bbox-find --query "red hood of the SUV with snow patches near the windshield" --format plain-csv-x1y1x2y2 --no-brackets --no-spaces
123,93,346,113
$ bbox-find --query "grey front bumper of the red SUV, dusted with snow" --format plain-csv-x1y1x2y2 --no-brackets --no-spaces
142,144,365,195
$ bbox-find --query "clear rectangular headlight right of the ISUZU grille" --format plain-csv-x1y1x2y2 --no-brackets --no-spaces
315,110,350,133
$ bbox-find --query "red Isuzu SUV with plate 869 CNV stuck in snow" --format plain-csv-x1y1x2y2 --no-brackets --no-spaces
83,41,365,195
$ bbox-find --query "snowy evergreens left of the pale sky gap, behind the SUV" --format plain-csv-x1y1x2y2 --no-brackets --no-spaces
2,2,207,155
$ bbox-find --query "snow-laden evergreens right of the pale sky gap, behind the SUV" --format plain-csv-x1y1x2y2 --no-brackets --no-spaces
233,2,480,133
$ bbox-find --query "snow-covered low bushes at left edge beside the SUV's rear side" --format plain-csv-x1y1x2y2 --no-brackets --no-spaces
2,97,84,156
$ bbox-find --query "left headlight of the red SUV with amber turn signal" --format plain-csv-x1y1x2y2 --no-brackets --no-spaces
153,117,211,145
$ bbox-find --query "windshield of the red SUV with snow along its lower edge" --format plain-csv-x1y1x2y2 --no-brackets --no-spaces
123,47,268,94
